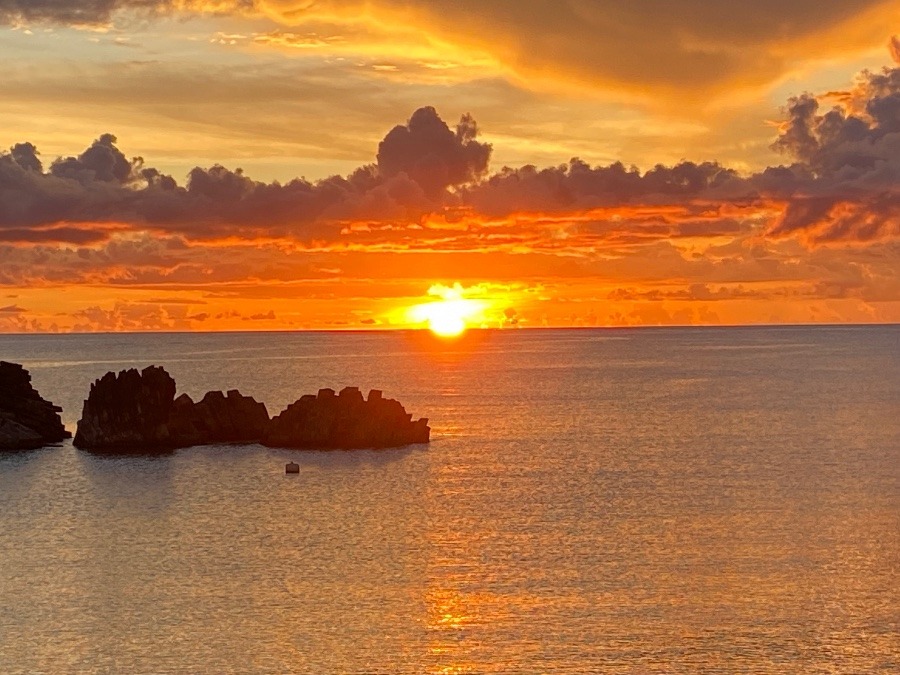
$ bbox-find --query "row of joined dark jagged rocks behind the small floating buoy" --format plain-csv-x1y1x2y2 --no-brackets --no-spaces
75,366,431,453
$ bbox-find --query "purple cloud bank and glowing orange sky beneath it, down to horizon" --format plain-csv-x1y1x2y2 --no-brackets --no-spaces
0,48,900,332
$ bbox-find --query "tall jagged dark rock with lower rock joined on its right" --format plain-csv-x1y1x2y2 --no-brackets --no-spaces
75,366,269,452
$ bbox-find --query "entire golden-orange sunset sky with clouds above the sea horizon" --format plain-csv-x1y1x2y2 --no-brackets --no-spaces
0,0,900,332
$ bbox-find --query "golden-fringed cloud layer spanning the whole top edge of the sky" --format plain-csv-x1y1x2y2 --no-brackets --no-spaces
0,0,900,105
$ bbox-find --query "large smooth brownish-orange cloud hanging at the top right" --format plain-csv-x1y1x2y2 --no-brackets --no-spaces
250,0,900,102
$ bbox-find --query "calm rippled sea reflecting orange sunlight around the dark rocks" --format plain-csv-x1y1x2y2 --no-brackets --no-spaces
0,326,900,674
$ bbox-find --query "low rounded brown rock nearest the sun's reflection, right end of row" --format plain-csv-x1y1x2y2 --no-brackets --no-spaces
263,387,431,450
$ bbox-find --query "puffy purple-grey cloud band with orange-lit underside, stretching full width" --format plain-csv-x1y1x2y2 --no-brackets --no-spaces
0,54,900,250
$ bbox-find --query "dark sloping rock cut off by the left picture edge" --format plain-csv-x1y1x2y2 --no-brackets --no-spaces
0,361,72,450
